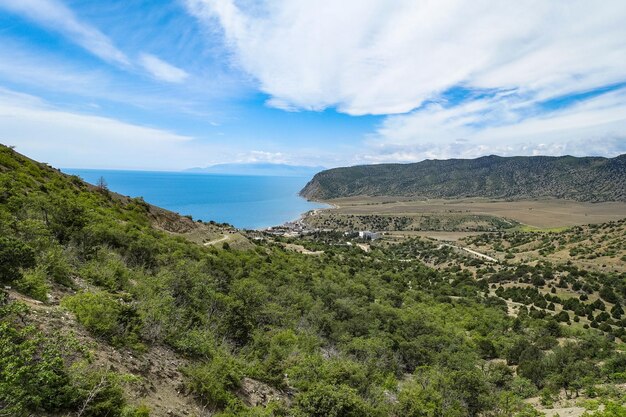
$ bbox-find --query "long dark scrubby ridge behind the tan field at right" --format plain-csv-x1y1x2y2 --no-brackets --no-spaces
300,154,626,202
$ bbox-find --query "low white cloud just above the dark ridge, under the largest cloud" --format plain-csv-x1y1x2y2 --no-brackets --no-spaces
359,89,626,162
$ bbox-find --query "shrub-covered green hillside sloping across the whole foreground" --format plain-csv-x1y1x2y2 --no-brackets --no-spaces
0,147,626,417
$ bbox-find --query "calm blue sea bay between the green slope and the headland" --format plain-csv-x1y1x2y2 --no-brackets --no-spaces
63,169,324,229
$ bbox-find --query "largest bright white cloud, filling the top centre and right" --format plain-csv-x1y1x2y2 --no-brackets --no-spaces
187,0,626,115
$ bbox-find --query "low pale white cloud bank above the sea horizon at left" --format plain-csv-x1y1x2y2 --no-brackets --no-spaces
0,89,219,169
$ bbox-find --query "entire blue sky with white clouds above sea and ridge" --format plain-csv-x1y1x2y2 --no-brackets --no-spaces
0,0,626,170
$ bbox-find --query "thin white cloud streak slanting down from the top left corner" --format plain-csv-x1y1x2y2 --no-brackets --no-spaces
0,0,129,66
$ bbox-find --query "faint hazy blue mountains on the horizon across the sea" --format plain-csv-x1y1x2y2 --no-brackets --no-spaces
187,162,324,177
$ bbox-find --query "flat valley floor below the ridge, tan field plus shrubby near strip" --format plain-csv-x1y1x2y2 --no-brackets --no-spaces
305,197,626,233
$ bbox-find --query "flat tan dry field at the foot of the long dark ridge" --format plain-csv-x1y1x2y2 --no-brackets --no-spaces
308,197,626,229
